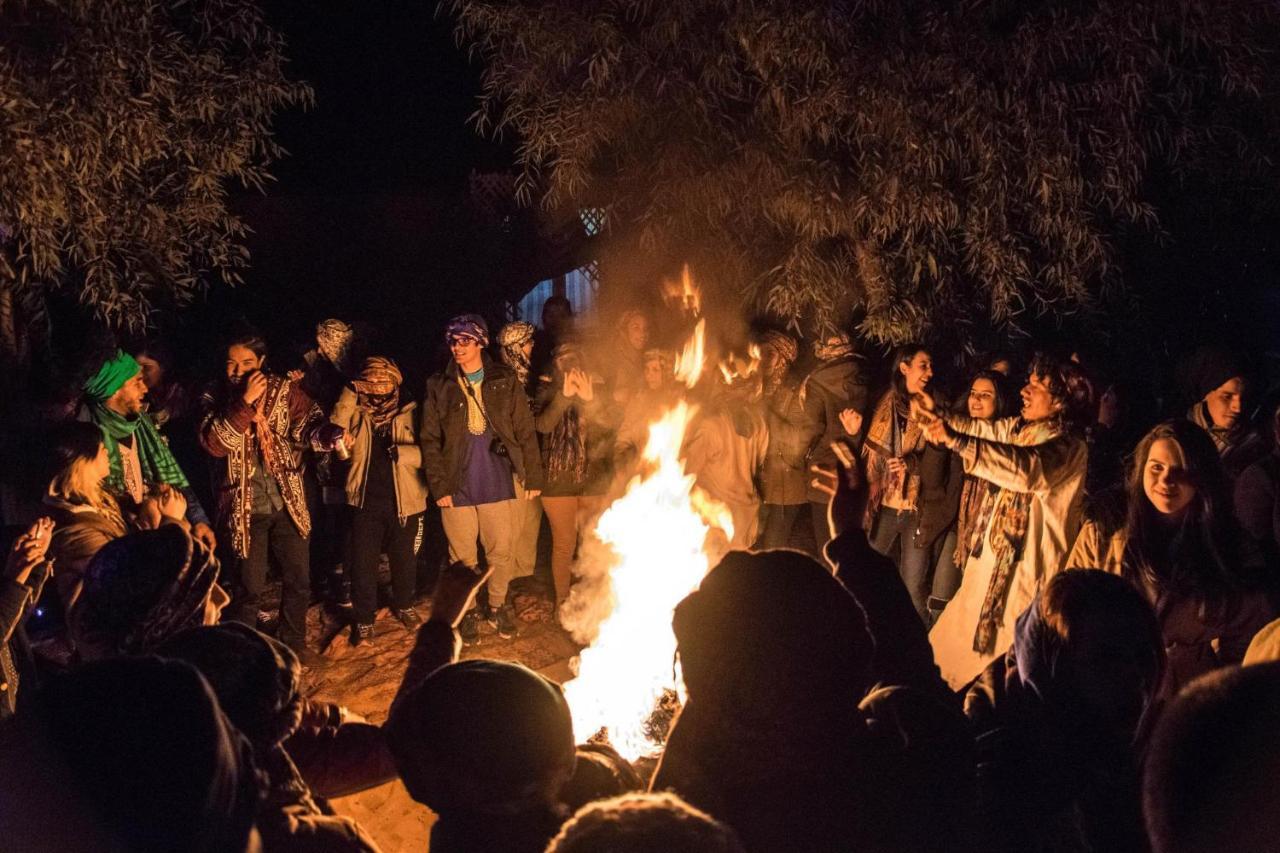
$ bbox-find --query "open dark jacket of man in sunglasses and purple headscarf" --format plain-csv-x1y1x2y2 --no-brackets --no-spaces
419,355,543,498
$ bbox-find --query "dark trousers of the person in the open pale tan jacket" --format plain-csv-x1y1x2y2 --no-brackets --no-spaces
347,507,422,625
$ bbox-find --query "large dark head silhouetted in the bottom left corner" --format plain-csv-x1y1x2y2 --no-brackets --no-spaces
0,657,262,853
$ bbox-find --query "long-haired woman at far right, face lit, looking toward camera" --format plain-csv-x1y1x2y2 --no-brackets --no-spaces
1066,420,1274,698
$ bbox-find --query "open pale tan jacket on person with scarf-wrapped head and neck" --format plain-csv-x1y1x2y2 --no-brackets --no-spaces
329,388,426,524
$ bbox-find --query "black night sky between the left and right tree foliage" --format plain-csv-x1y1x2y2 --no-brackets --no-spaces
207,0,511,371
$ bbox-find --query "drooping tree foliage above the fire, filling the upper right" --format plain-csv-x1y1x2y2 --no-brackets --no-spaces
442,0,1280,342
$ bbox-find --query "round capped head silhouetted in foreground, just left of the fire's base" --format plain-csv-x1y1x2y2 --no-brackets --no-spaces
384,661,575,820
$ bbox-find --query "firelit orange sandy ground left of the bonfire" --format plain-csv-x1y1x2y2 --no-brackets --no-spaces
306,580,577,853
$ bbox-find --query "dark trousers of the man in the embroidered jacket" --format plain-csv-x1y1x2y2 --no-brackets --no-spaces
232,510,311,647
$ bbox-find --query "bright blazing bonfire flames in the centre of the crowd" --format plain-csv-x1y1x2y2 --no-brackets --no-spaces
564,308,733,760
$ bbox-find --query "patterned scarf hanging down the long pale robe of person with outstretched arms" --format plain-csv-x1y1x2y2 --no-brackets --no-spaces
973,421,1061,654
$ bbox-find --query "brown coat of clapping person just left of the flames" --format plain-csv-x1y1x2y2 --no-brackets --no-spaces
534,375,622,497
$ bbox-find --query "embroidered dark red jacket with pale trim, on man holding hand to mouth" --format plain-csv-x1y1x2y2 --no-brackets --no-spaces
200,375,329,558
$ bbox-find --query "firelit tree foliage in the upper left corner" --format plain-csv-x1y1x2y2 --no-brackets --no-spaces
0,0,311,348
